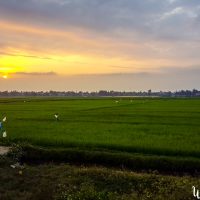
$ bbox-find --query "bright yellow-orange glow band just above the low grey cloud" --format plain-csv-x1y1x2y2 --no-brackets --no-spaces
0,54,162,75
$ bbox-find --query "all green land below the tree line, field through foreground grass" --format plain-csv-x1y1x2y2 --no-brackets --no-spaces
0,98,200,200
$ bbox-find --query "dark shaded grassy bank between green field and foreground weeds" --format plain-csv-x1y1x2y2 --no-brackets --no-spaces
11,145,200,175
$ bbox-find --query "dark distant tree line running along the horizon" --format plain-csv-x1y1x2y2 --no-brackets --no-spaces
0,89,200,97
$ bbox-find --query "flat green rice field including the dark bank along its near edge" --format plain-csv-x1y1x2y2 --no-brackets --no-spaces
0,98,200,172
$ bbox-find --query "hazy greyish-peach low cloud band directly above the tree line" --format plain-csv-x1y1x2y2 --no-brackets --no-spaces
0,66,200,91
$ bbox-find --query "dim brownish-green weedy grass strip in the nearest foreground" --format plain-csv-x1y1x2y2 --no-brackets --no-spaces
0,157,200,200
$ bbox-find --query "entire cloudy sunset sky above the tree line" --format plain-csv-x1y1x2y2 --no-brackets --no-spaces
0,0,200,91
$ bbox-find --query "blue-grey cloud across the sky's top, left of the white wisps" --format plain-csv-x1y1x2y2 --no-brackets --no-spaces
0,0,195,35
